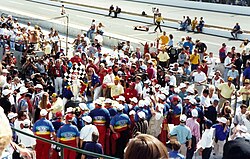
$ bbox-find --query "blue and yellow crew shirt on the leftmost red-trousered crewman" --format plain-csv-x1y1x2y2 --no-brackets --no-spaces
32,118,55,135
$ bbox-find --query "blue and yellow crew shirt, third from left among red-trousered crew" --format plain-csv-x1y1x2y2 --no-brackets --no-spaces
89,108,110,126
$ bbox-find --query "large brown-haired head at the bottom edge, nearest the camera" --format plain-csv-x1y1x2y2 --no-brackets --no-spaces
124,134,168,159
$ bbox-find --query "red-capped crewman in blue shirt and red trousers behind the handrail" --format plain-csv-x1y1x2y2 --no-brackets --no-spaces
56,114,80,159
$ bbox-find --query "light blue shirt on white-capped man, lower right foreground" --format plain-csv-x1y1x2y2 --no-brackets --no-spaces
170,125,192,144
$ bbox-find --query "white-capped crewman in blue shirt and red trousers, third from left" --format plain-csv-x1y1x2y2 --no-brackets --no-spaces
89,99,110,150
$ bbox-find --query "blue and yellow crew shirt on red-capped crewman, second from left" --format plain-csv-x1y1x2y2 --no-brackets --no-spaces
56,124,80,141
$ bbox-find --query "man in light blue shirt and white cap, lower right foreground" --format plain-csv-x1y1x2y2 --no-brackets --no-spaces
170,114,192,156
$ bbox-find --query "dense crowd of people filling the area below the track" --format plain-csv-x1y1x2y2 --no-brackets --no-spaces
0,9,250,159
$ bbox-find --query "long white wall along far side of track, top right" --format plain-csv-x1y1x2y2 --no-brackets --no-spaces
127,0,250,16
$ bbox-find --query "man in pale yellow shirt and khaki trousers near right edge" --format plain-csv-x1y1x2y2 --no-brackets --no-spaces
217,77,235,112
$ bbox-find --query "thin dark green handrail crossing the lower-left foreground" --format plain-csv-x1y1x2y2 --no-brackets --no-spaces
11,128,117,159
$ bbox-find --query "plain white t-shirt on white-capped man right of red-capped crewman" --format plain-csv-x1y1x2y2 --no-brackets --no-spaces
80,124,99,141
